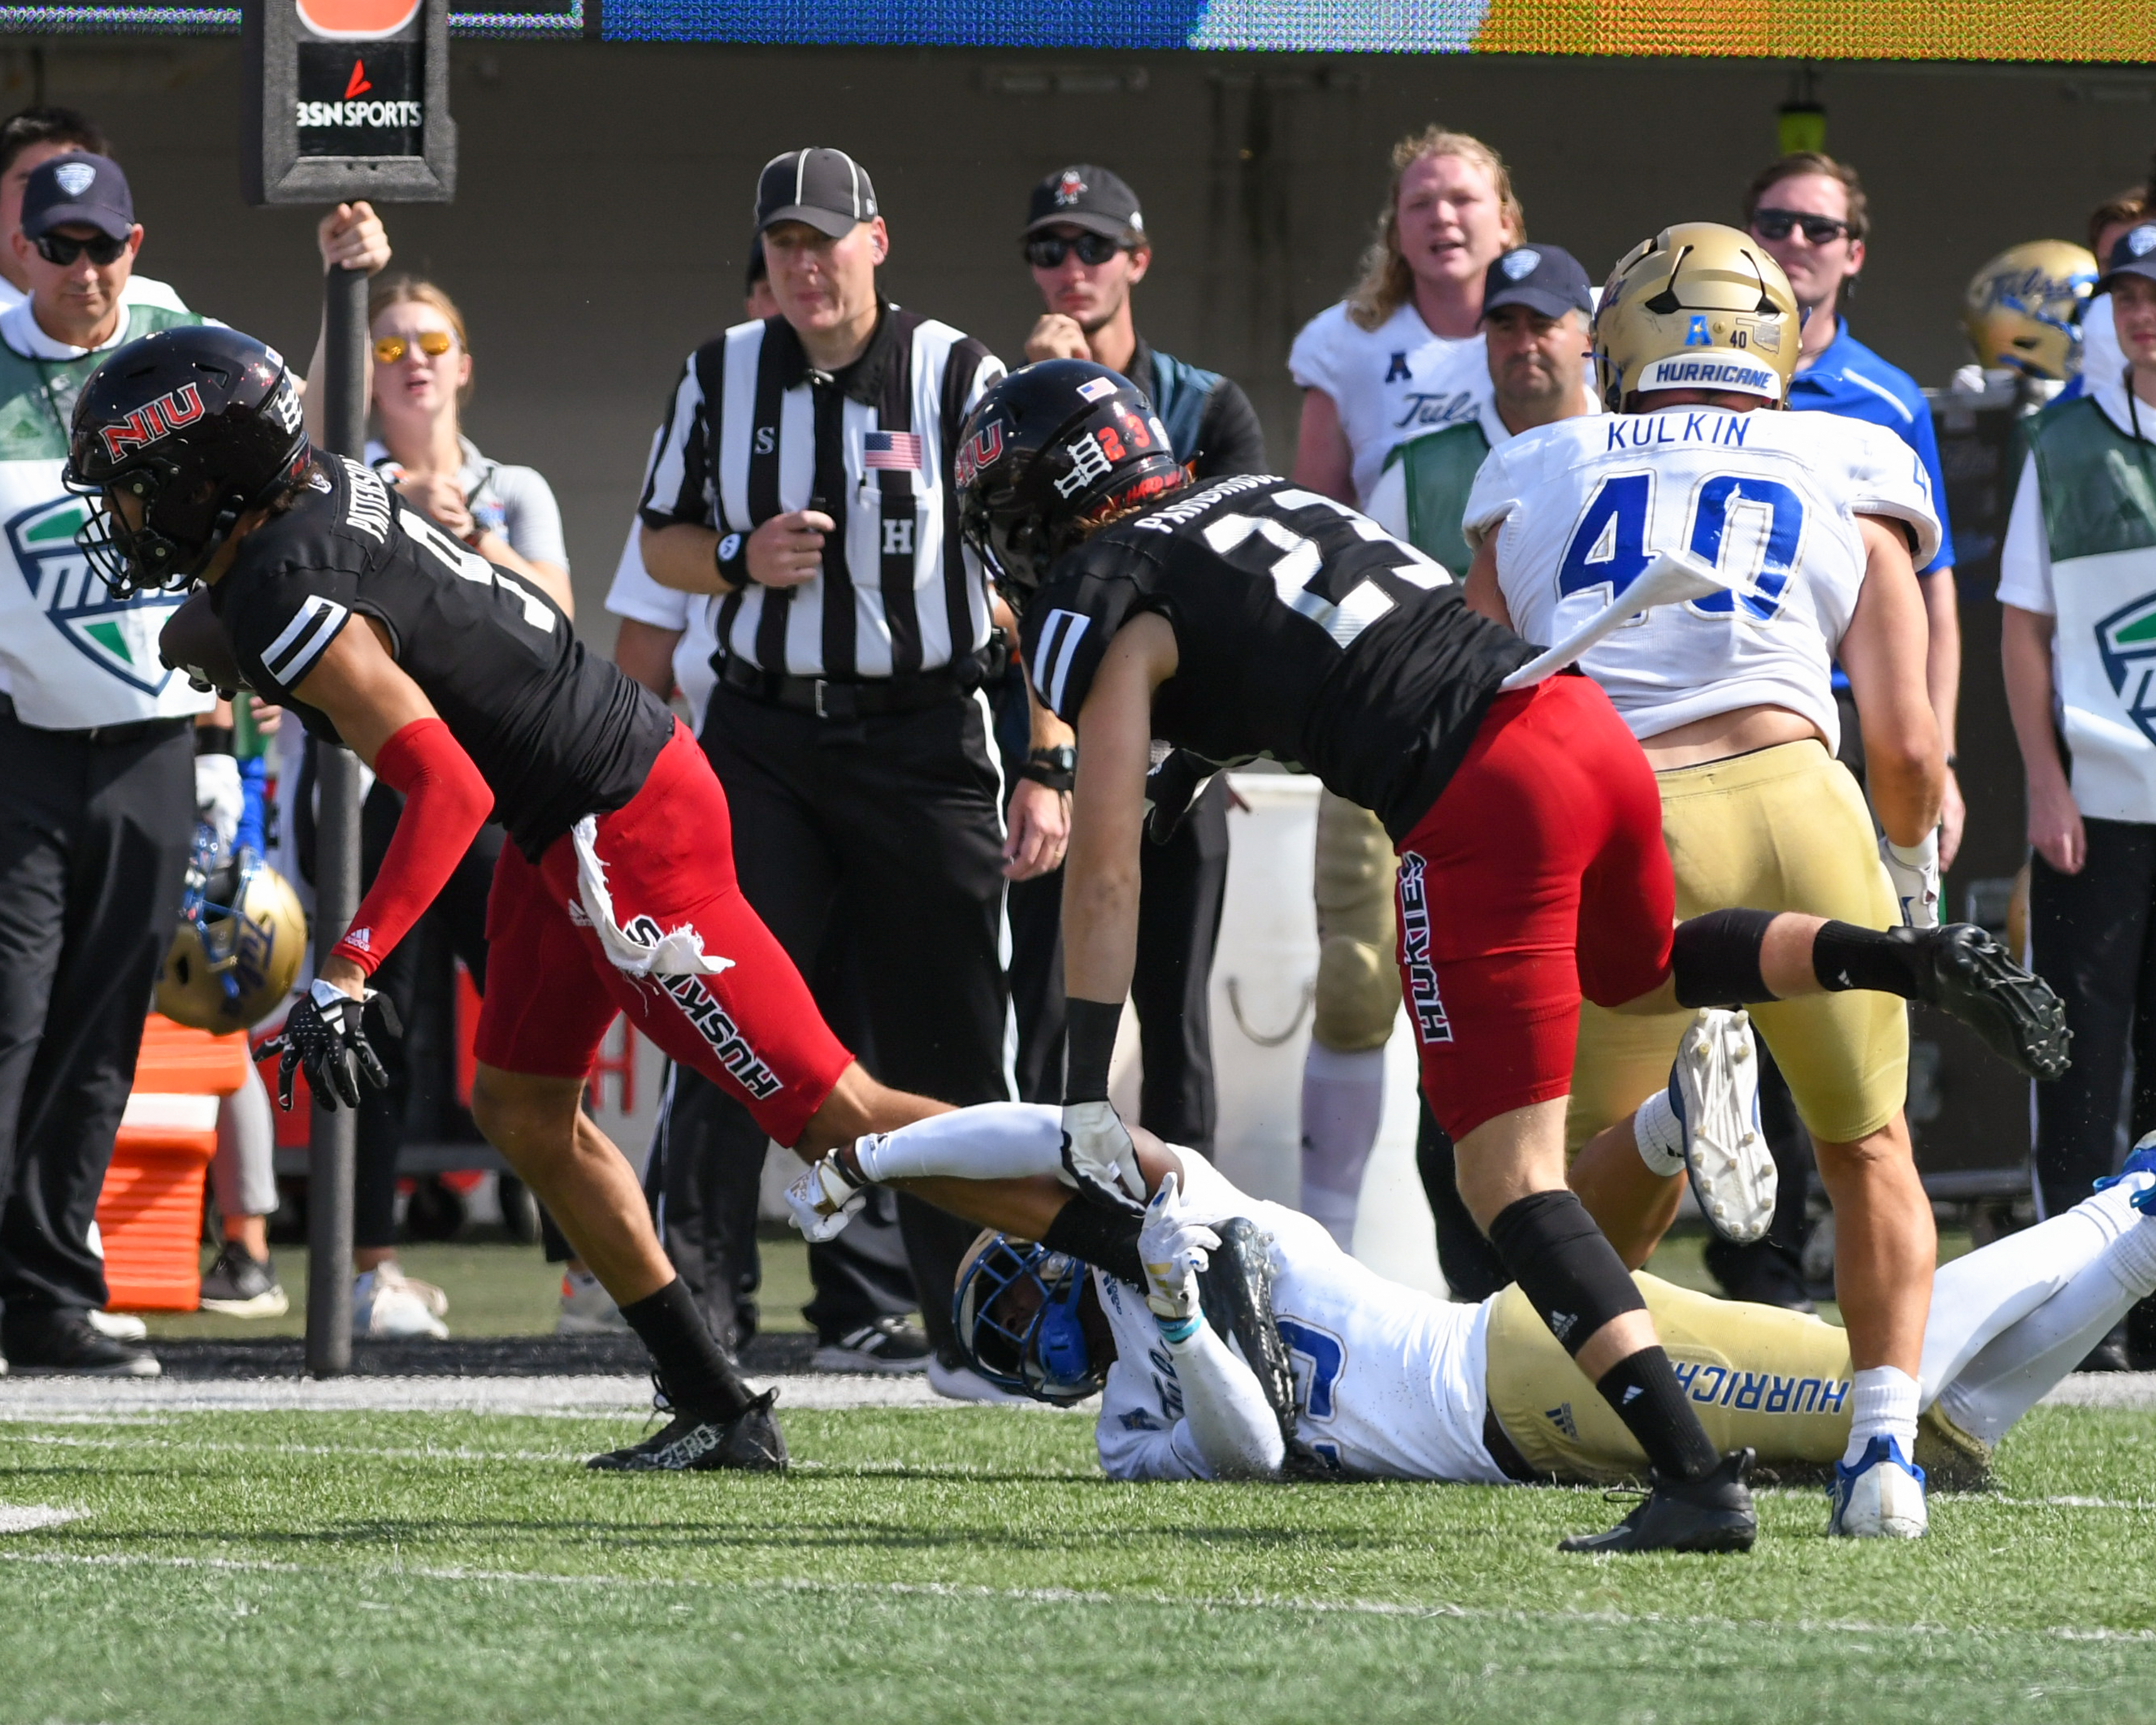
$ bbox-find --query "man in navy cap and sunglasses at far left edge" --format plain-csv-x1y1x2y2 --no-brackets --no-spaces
0,151,245,1376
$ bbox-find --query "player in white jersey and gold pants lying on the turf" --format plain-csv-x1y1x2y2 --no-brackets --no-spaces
789,1102,2156,1518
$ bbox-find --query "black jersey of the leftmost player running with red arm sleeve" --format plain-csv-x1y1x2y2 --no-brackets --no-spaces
211,457,673,862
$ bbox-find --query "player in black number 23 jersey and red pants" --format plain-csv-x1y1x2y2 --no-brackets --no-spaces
957,360,2063,1550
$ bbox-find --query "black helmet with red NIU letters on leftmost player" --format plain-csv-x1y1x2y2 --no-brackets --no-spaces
63,323,313,599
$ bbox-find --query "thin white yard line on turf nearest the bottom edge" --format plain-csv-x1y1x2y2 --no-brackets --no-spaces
0,1550,2156,1643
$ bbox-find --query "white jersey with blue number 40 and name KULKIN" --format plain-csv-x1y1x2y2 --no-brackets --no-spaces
1464,408,1938,748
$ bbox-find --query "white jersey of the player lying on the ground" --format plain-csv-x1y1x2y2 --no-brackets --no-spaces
1093,1149,1505,1486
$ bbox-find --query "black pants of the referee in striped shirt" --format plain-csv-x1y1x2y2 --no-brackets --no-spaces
681,688,1009,1363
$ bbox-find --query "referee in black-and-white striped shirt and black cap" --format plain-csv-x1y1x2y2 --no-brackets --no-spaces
640,149,1069,1386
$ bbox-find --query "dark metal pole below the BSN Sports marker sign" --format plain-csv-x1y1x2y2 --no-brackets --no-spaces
306,257,367,1378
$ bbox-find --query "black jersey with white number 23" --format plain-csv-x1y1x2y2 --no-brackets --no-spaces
1024,474,1535,839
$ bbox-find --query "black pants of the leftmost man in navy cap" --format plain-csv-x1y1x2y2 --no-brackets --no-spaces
0,705,194,1309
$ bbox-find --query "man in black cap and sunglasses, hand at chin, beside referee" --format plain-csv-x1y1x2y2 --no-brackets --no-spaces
1011,162,1268,1154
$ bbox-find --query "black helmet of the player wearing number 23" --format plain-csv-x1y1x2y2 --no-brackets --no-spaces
953,360,1188,606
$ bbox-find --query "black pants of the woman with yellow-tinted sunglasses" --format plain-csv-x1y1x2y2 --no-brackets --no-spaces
351,781,507,1251
